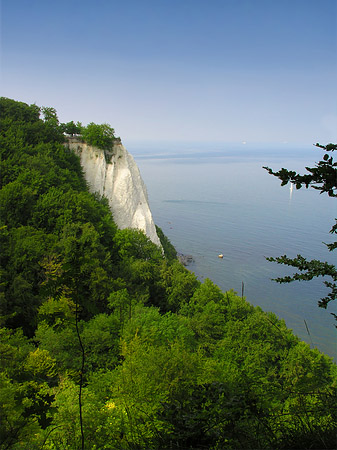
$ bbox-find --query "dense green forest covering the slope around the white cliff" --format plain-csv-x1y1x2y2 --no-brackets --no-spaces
0,98,337,450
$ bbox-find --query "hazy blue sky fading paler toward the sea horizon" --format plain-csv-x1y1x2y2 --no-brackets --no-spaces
0,0,337,145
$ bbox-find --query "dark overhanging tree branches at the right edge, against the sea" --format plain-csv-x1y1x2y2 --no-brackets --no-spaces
263,143,337,320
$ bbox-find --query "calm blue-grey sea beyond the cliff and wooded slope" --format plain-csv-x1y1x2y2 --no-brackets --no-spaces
127,143,337,359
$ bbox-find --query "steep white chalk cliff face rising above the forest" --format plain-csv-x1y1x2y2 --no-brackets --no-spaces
68,139,161,247
